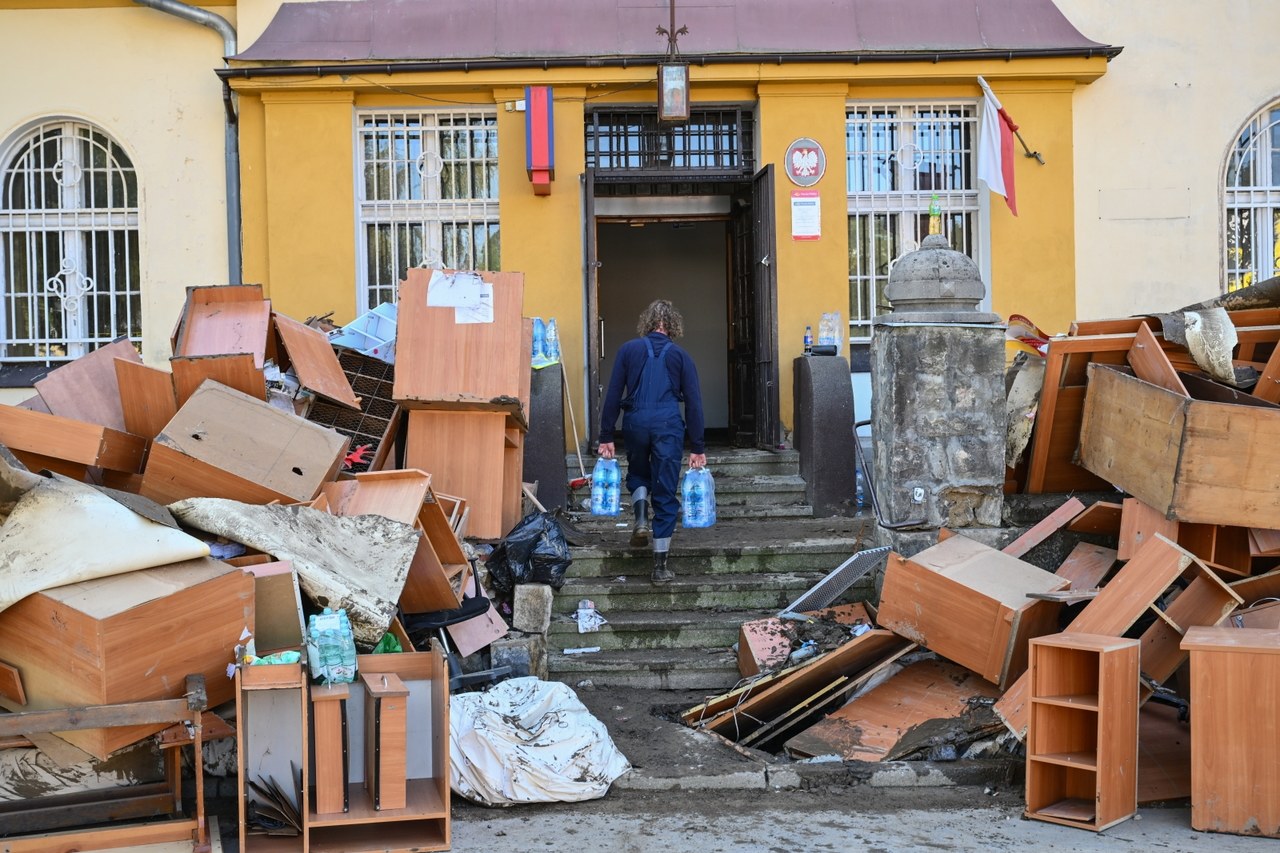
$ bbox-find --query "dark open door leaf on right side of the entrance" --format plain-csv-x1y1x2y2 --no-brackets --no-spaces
728,164,781,450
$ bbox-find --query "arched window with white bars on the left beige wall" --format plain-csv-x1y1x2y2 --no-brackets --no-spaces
0,119,142,364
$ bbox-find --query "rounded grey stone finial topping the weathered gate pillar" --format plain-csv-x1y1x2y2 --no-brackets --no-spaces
879,234,1001,323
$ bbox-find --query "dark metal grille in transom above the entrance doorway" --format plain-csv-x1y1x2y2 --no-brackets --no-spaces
586,106,755,182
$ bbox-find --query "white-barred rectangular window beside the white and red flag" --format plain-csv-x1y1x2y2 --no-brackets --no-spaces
845,104,984,343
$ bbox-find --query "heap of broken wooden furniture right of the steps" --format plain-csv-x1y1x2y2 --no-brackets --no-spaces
684,280,1280,838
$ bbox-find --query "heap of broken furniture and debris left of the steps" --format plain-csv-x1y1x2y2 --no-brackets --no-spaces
0,269,531,852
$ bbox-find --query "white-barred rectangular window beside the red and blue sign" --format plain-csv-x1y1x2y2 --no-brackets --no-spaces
356,110,502,311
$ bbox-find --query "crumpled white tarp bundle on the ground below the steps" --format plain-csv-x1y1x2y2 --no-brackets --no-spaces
449,678,631,806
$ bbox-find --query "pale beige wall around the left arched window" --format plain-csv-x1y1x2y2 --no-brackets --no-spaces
0,6,234,366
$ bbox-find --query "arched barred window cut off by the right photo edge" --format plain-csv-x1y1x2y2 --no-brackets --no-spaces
1222,102,1280,291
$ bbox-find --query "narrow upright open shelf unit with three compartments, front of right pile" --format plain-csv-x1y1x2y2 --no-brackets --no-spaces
1027,634,1139,831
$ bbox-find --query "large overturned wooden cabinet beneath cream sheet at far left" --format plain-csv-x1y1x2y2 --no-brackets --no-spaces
0,557,255,758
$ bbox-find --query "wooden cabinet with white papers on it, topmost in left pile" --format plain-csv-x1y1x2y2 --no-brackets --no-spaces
396,268,529,414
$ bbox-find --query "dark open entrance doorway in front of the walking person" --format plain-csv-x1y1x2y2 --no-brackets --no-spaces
596,218,730,442
